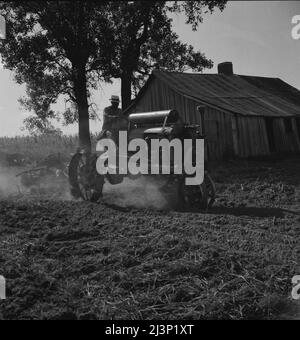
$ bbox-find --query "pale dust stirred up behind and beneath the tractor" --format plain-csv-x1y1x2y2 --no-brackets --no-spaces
0,166,170,210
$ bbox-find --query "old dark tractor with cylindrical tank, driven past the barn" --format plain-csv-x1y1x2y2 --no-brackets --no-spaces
69,107,216,210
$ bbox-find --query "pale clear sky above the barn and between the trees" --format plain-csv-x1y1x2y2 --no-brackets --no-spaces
0,1,300,137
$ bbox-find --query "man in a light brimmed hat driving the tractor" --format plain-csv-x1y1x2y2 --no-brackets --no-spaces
99,95,128,144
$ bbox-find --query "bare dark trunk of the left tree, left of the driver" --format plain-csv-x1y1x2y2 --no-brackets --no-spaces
74,65,92,151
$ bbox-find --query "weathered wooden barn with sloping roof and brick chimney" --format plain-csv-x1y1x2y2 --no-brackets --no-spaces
126,62,300,160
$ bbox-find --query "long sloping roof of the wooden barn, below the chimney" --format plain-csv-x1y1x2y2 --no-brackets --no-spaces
131,70,300,117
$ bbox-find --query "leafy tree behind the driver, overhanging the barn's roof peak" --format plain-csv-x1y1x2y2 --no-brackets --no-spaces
104,0,226,109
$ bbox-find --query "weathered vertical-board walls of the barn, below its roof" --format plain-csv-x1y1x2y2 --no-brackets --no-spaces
130,78,300,160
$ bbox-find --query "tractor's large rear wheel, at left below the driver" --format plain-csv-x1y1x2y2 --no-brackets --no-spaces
69,153,104,202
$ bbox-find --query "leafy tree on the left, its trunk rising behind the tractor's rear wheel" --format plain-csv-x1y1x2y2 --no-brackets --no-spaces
0,1,110,149
